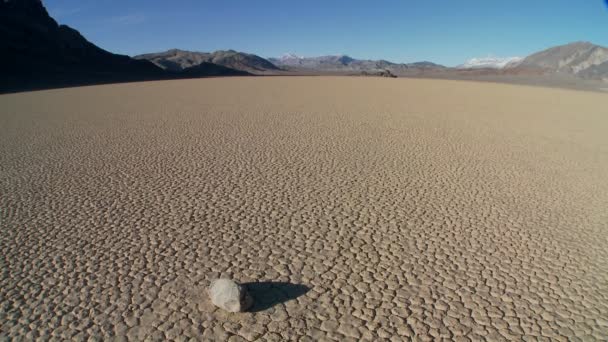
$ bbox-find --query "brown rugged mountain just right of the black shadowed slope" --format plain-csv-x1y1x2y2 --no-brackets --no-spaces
134,49,279,74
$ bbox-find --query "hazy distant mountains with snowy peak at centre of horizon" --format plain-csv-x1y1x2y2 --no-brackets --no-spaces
268,54,445,74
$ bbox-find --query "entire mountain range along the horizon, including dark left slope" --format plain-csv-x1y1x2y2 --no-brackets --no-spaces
0,0,608,92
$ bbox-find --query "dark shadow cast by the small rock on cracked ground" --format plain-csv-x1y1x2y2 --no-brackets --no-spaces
242,281,310,312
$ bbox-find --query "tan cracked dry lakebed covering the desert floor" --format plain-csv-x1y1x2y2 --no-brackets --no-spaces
0,77,608,341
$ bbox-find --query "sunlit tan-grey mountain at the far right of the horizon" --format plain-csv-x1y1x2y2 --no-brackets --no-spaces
515,42,608,79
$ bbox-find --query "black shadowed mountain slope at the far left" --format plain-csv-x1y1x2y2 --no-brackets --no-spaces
0,0,163,89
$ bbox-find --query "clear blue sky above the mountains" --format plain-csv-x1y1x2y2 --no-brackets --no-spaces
43,0,608,66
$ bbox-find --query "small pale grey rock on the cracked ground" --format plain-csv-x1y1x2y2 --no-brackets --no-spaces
209,279,253,312
